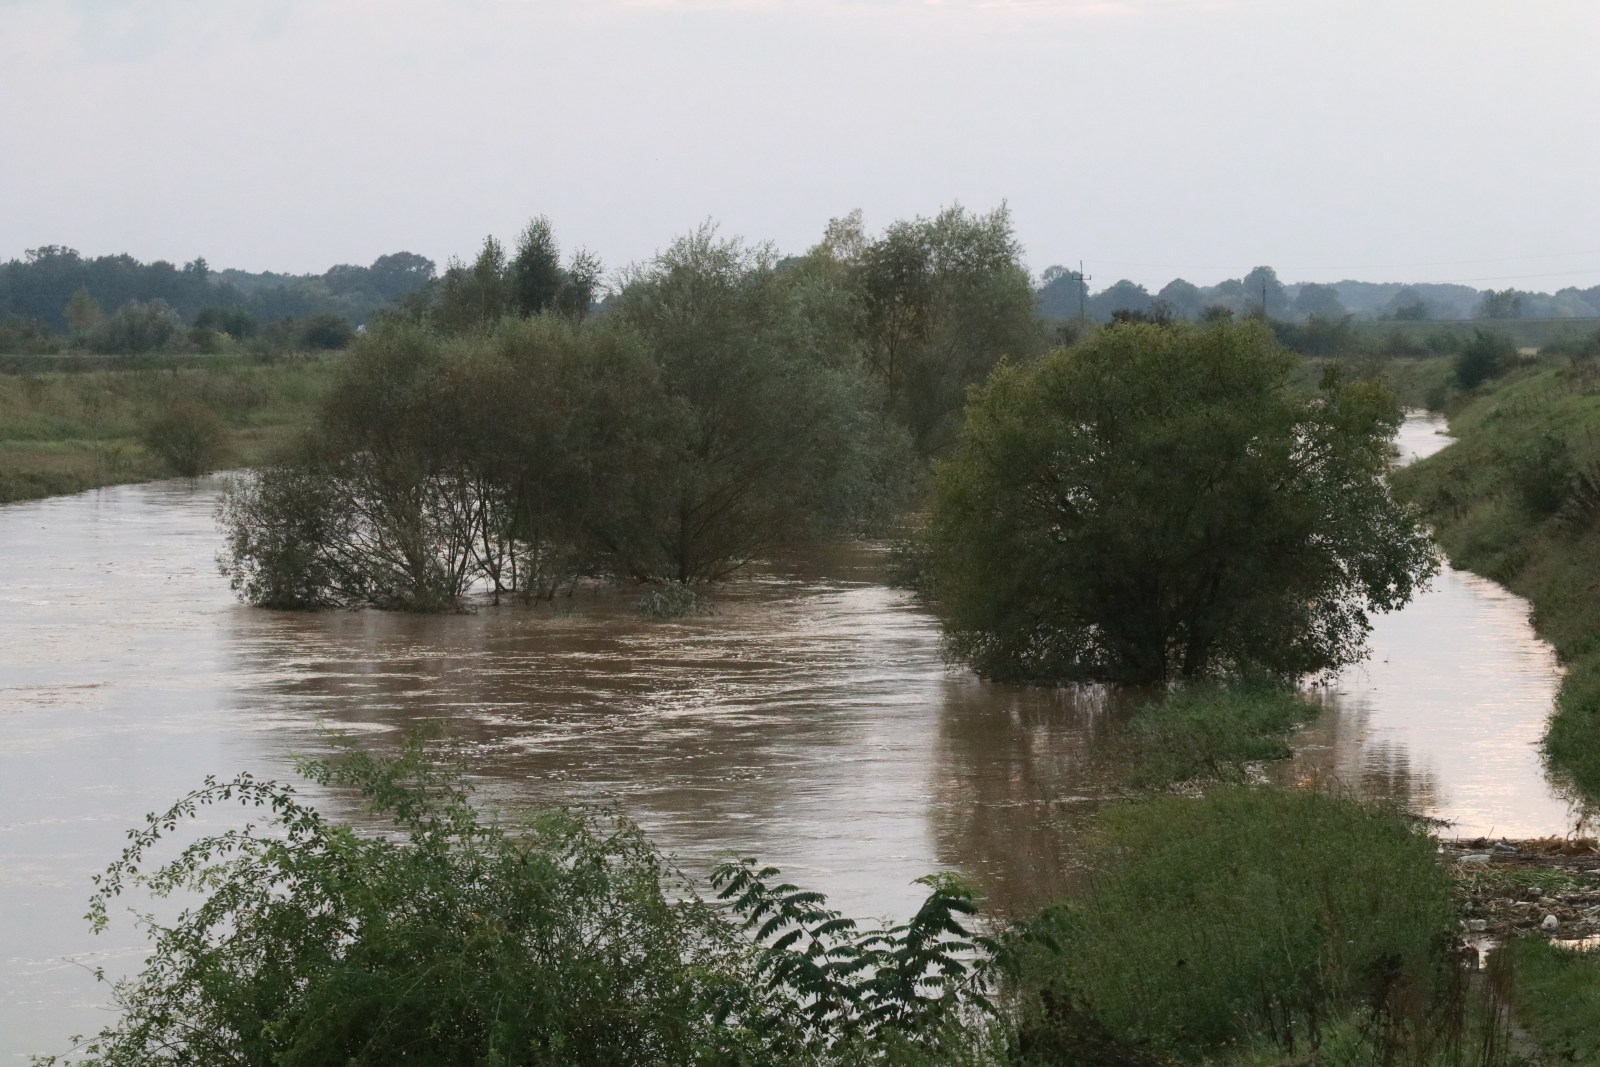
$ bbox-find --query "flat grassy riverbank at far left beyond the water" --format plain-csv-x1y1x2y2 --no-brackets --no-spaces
0,357,334,502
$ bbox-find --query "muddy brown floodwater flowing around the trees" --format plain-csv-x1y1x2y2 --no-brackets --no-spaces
0,419,1574,1064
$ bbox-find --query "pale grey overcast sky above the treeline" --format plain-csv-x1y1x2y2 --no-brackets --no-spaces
0,0,1600,291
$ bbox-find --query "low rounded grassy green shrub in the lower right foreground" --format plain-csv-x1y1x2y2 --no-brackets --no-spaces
1018,787,1459,1064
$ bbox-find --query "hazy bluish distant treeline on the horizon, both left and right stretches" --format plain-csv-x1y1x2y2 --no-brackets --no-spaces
9,227,1600,355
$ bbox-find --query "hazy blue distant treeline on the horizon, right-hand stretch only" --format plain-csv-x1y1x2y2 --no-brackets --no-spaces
1038,266,1600,323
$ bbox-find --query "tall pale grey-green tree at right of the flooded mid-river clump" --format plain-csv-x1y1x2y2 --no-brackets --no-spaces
613,227,904,582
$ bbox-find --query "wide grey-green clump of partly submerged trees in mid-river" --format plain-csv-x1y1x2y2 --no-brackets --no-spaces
221,229,912,611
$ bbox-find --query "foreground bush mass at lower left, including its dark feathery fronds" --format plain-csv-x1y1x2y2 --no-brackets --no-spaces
46,747,987,1067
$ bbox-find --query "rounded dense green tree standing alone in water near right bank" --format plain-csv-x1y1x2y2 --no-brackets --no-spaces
931,323,1435,681
